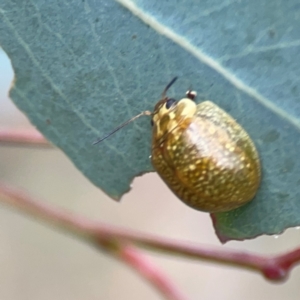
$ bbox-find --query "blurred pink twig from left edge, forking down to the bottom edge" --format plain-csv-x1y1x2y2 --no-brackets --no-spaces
0,184,187,300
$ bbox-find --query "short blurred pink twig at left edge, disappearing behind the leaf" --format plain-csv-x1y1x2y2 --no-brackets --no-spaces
0,129,52,147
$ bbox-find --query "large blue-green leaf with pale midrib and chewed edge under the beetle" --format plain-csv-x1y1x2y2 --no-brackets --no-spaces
0,0,300,241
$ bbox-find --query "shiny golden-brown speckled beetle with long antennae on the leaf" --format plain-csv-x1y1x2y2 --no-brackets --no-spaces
94,78,261,212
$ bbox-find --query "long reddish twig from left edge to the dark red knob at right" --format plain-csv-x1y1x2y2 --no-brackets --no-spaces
0,184,300,281
